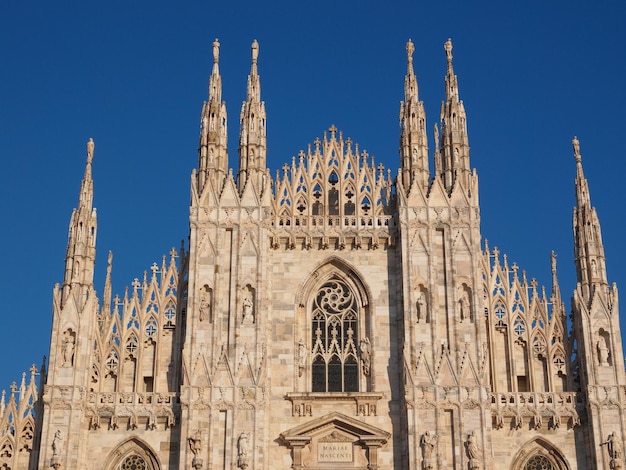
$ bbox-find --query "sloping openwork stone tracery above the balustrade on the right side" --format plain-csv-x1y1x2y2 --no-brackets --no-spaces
483,244,570,393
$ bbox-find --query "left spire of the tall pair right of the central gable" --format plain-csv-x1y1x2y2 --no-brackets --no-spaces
400,39,430,190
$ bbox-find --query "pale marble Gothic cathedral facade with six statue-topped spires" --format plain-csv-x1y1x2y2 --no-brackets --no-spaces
0,40,626,470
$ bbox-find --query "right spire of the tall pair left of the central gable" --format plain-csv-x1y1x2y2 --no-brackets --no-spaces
237,39,267,191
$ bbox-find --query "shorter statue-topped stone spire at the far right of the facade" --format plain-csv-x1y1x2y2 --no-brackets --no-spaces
572,137,608,301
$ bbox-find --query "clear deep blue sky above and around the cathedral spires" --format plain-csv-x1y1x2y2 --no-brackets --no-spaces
0,0,626,389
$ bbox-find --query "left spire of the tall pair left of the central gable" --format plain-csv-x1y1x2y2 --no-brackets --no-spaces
198,38,228,190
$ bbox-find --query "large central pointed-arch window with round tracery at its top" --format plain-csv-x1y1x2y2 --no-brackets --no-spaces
311,276,359,392
